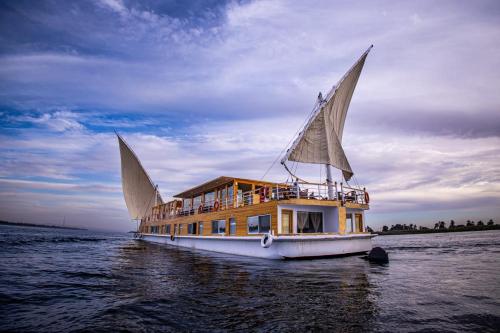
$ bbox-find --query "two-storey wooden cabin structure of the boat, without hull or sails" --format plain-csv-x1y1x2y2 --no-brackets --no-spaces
140,177,369,237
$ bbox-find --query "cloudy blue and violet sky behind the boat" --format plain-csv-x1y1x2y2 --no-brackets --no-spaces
0,0,500,231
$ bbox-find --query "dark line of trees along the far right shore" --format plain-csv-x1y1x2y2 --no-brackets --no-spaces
376,219,500,235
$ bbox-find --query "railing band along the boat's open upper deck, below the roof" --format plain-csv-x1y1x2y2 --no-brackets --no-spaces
146,182,367,221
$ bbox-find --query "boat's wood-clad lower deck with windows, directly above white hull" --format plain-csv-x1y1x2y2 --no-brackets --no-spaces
139,199,368,238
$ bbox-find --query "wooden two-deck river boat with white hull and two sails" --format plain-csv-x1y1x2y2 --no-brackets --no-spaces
117,45,374,259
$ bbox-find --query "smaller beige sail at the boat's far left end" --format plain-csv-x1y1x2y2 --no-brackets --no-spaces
116,134,163,219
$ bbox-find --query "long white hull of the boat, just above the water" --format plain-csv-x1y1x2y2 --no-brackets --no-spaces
141,234,374,259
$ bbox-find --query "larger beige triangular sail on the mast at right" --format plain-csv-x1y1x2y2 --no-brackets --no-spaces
282,46,372,180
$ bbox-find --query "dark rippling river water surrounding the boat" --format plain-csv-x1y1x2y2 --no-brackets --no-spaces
0,226,500,332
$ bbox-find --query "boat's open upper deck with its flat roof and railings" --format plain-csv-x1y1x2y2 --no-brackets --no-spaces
145,176,369,222
